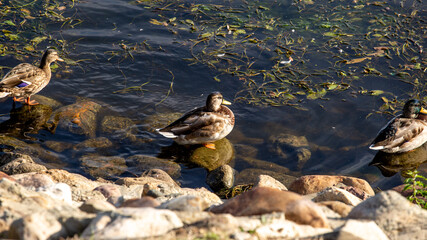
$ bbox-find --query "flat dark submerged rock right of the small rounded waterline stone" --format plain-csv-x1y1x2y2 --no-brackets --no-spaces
235,168,296,186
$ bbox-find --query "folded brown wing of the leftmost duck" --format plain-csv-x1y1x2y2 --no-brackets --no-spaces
0,63,45,88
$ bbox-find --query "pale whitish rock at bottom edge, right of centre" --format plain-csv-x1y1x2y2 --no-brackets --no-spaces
337,220,388,240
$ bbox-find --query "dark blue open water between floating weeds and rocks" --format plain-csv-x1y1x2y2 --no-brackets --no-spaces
0,0,425,191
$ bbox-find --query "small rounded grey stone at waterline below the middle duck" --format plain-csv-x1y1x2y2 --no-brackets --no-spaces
206,165,235,192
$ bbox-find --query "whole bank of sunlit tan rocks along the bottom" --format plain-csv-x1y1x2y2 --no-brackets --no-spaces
0,153,427,239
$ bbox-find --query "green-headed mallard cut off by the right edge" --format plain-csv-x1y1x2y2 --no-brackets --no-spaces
369,99,427,153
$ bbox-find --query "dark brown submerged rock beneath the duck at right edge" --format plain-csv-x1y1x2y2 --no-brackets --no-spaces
369,143,427,177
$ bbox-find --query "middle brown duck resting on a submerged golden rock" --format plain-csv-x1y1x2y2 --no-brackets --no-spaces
157,92,234,149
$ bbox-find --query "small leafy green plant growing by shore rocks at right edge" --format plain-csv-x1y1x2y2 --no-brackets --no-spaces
403,170,427,209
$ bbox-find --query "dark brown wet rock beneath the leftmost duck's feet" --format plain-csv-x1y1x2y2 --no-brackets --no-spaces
0,104,52,139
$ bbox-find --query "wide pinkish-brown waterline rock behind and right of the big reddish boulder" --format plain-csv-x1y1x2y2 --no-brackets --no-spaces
288,175,375,196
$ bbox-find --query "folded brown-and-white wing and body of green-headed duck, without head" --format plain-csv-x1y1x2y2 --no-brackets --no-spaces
369,117,427,152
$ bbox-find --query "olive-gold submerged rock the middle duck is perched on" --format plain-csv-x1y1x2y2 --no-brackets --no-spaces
186,138,234,171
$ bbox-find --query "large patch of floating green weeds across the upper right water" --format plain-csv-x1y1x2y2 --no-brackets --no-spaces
134,0,427,109
